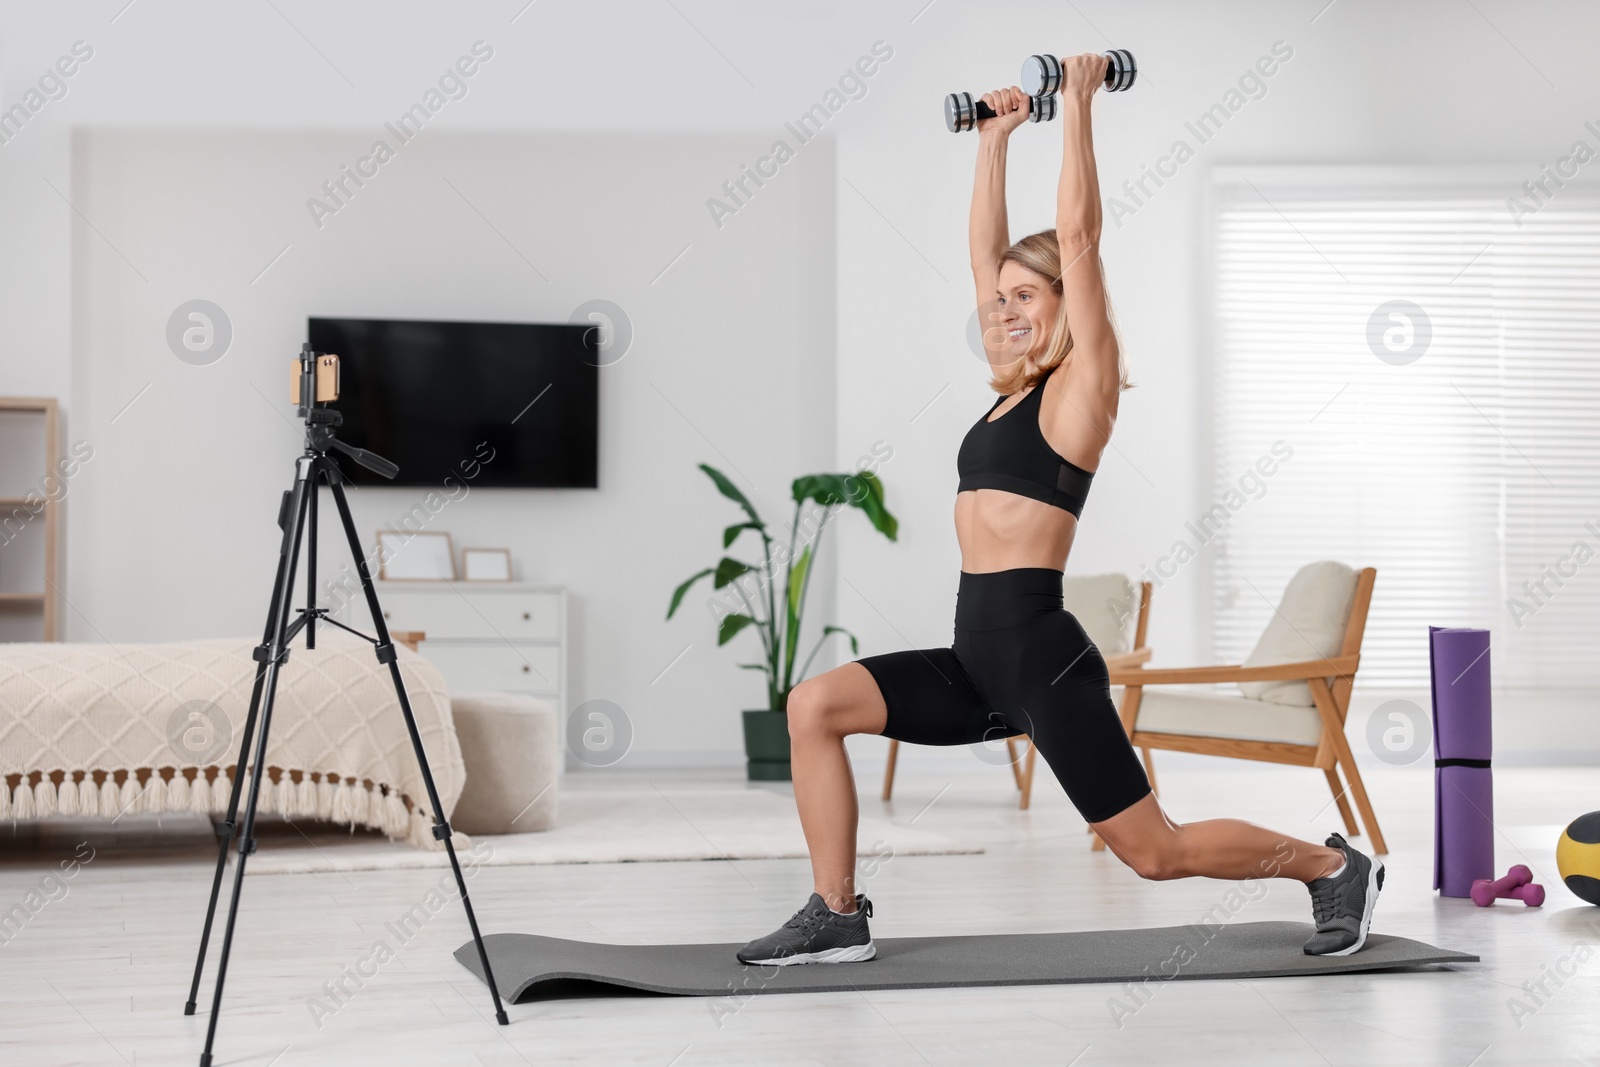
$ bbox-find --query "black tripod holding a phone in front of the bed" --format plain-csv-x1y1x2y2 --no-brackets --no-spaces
184,346,509,1067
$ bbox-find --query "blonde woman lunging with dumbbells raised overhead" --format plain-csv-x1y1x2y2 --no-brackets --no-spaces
739,56,1382,965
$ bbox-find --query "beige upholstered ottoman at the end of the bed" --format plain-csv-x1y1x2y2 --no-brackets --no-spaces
450,693,562,833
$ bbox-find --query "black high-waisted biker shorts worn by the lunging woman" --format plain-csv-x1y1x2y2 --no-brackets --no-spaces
856,566,1150,822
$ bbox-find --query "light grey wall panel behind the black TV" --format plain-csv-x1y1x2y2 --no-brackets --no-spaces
60,128,834,758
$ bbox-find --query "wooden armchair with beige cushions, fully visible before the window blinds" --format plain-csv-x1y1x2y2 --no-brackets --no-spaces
1094,561,1389,853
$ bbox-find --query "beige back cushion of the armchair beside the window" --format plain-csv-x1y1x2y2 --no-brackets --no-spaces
1238,560,1357,707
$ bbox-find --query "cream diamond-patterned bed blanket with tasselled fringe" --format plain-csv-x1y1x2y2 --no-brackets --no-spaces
0,625,466,848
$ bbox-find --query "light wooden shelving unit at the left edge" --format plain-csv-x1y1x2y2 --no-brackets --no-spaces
0,397,61,641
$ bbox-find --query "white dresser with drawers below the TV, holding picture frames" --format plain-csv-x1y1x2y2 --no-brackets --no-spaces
352,582,566,717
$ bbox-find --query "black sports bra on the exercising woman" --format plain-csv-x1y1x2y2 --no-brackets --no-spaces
955,379,1094,517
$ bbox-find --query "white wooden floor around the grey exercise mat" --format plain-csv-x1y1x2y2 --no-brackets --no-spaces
0,755,1600,1067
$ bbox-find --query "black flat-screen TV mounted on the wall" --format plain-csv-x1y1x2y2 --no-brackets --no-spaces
307,318,600,490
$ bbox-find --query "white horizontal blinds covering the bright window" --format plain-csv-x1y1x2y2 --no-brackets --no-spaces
1213,181,1600,688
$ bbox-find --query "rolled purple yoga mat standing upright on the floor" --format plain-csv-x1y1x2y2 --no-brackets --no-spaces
1427,625,1494,897
